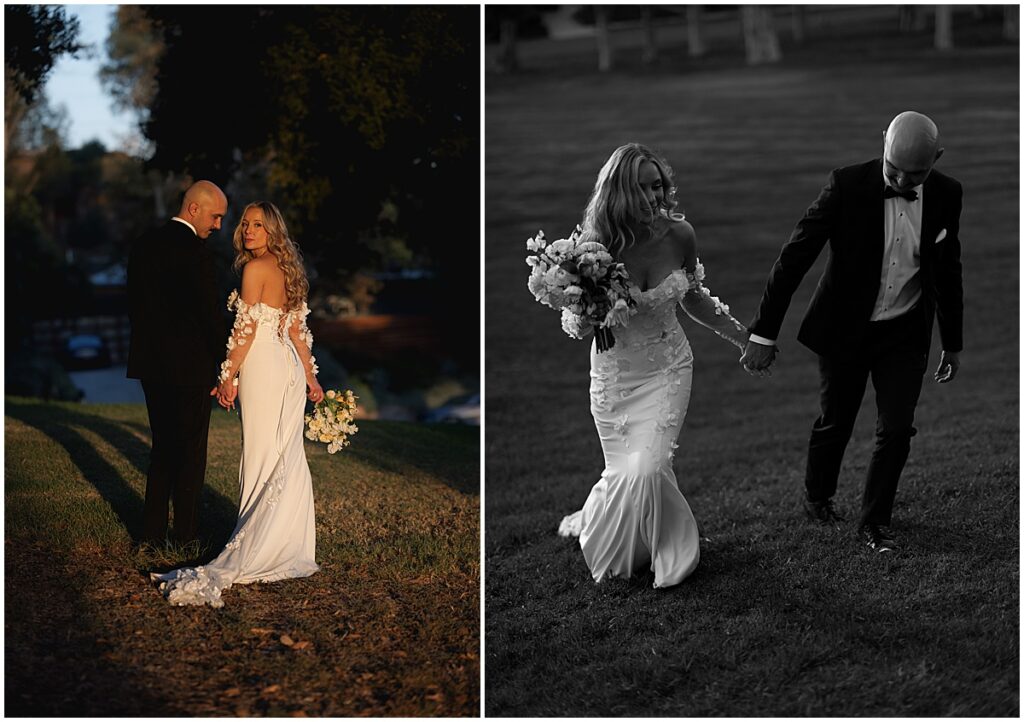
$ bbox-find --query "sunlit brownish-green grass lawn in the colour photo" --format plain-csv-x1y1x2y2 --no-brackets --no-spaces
4,397,480,717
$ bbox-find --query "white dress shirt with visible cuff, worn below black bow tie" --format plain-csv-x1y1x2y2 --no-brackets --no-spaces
751,175,925,346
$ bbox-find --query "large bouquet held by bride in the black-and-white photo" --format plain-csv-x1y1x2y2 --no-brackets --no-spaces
526,225,636,353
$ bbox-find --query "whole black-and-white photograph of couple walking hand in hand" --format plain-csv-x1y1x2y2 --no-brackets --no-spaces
483,5,1020,718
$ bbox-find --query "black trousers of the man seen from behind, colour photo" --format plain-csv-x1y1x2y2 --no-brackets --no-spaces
142,381,211,544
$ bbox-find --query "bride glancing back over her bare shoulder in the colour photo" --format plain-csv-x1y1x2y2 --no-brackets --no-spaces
152,202,324,606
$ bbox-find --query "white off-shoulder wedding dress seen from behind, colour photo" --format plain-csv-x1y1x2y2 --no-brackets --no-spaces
151,292,318,607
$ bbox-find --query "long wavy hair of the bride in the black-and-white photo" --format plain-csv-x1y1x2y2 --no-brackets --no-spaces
583,143,683,258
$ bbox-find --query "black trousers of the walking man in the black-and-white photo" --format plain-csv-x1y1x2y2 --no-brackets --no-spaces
806,306,928,525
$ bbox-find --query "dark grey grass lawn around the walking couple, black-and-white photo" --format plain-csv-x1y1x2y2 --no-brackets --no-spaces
484,14,1020,717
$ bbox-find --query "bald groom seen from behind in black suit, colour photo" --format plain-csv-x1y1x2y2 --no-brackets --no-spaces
128,180,227,545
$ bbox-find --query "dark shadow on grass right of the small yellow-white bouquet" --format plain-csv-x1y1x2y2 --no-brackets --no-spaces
343,421,480,496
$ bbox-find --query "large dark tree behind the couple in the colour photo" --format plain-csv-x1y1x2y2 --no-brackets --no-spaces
130,5,480,362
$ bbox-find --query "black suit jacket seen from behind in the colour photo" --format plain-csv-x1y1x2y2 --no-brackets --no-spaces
128,220,227,388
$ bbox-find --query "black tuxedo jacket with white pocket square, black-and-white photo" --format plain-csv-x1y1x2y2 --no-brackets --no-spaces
750,158,964,356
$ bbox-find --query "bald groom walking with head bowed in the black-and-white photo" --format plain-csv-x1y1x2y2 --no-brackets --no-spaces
740,111,964,552
